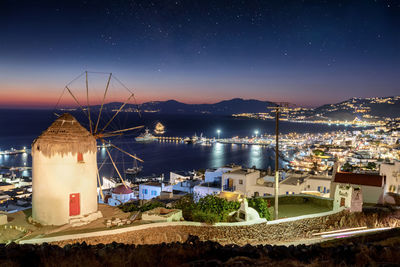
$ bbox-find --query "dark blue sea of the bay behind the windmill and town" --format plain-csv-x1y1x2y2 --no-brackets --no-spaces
0,109,352,182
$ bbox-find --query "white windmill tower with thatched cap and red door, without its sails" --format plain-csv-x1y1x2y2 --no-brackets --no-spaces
32,113,97,225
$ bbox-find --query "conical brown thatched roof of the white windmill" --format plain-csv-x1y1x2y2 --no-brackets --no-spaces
32,113,97,156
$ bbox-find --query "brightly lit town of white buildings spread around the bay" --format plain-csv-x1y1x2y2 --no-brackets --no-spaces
0,117,400,218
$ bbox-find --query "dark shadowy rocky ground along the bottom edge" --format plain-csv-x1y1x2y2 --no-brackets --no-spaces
0,229,400,267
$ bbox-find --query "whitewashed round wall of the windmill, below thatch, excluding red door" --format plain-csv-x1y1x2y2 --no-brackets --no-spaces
32,151,97,225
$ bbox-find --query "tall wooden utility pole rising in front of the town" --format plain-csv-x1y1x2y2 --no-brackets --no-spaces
269,102,291,220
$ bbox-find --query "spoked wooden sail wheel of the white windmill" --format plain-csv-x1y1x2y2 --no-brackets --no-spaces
54,71,143,200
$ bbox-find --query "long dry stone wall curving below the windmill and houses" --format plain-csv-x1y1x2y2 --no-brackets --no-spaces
52,211,400,246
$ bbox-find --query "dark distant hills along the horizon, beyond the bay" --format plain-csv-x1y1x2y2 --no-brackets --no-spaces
92,96,400,120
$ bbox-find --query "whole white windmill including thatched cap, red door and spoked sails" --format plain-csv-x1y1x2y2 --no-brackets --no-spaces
32,71,143,226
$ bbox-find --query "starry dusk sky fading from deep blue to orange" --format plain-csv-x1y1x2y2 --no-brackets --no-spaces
0,0,400,107
